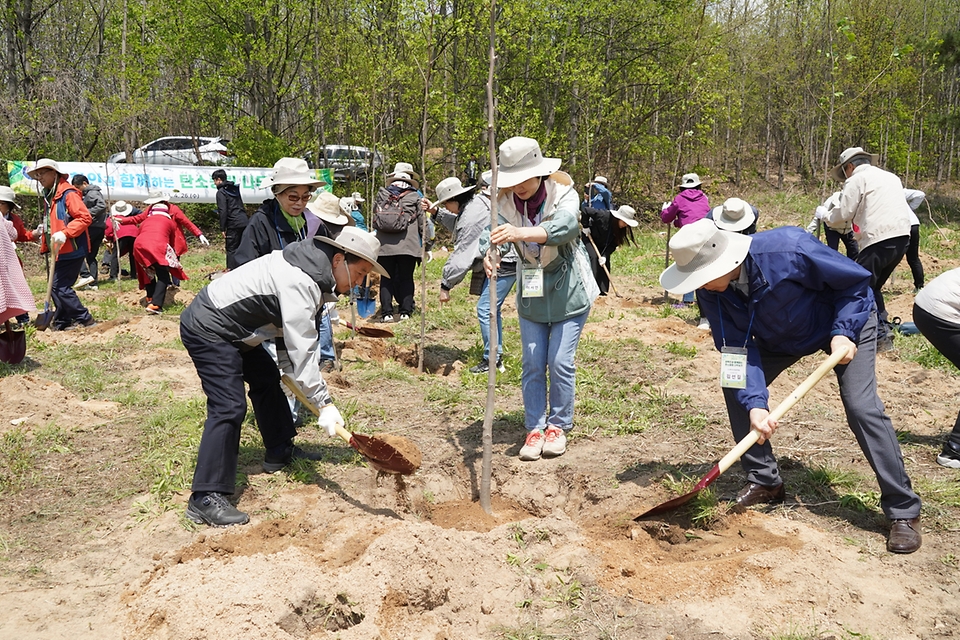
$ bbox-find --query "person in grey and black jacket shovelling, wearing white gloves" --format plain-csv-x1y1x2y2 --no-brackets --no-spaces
180,227,386,526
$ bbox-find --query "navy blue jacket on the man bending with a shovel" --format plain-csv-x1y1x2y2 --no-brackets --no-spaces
697,227,874,411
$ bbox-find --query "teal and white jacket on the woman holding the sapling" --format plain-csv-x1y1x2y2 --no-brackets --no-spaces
480,171,600,324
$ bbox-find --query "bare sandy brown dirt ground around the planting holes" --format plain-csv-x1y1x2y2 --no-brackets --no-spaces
0,239,960,640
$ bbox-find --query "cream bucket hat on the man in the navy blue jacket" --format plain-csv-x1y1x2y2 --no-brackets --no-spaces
660,218,753,294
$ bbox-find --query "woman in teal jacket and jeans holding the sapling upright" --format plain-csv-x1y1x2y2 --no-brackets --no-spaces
481,137,600,460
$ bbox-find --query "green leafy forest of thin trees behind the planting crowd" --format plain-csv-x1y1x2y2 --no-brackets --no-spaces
0,0,960,209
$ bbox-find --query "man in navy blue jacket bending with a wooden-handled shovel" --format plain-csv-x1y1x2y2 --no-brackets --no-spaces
660,220,921,553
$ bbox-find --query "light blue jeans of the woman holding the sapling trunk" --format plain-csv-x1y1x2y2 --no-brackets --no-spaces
520,310,590,431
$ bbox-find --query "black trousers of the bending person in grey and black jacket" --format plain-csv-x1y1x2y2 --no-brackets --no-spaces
180,325,297,494
